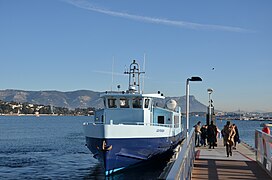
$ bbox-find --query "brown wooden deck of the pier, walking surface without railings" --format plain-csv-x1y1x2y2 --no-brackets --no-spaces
192,139,272,180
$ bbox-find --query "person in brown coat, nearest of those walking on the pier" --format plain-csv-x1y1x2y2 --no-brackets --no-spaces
223,121,235,157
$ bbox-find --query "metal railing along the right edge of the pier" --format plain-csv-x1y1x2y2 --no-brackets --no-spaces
255,130,272,177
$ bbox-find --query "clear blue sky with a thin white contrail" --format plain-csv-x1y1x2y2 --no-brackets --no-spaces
0,0,272,112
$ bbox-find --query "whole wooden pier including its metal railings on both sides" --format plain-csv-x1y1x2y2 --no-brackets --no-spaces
161,130,272,180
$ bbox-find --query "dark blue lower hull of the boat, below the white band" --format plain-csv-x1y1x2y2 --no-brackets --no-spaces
86,133,182,174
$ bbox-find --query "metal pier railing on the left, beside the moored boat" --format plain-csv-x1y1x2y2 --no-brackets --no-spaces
166,129,195,180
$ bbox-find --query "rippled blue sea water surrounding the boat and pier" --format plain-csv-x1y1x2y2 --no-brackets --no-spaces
0,116,268,179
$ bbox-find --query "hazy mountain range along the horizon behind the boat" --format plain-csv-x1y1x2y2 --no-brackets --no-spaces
0,89,207,112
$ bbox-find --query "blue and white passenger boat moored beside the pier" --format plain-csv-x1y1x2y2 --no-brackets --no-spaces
83,60,184,175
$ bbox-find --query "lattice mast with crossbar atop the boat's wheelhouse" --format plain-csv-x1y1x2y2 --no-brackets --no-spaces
125,60,145,93
